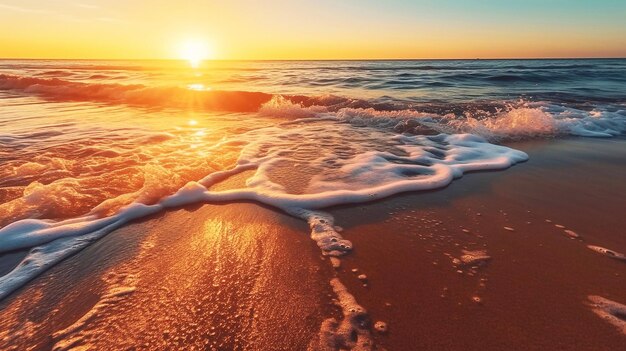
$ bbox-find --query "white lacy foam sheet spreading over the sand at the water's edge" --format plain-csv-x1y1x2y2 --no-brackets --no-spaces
0,119,527,298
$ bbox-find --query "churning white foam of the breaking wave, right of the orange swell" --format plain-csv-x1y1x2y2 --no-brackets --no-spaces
262,99,626,141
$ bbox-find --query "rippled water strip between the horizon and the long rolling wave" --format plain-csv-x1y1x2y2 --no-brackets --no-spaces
0,59,626,103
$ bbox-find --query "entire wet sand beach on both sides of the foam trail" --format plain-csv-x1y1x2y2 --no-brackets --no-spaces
0,138,626,350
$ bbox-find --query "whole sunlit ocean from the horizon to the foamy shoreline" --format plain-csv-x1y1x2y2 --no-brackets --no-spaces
0,59,626,306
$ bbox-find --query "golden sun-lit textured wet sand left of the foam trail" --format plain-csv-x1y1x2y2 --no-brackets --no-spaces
0,204,328,350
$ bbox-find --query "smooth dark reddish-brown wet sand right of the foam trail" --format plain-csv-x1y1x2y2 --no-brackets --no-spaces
332,139,626,350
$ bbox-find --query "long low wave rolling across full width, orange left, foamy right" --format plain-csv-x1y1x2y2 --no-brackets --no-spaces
0,74,626,141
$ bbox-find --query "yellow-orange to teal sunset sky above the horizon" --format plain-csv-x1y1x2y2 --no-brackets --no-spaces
0,0,626,60
